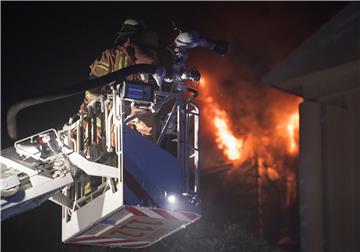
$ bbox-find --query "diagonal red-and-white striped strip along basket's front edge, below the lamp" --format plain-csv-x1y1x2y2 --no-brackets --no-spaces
126,206,200,222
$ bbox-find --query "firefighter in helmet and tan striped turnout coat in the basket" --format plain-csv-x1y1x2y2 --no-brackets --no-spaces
80,19,158,138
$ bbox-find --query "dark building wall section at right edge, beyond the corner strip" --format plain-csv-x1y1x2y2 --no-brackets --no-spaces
323,91,360,251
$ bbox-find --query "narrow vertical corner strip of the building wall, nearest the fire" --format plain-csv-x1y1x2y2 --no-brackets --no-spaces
299,101,323,251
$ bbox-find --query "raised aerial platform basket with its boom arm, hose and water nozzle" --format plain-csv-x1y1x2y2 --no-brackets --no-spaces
0,26,227,248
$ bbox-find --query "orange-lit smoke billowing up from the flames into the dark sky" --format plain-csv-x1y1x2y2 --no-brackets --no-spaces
184,3,339,169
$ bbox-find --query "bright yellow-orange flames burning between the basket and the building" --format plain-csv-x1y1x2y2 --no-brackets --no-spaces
200,78,300,164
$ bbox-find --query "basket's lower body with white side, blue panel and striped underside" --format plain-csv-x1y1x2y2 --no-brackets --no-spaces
62,127,201,248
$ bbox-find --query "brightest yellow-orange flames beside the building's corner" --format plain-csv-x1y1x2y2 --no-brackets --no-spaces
200,78,300,163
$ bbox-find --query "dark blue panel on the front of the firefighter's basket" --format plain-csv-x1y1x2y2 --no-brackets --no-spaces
124,126,184,207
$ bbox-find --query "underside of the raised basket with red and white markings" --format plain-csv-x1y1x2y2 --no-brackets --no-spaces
68,206,201,248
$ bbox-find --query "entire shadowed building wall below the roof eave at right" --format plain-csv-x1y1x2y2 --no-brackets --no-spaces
299,87,360,251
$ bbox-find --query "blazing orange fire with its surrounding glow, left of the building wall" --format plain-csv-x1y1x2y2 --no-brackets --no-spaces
199,75,302,209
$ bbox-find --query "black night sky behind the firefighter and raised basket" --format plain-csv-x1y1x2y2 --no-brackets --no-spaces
1,2,346,251
